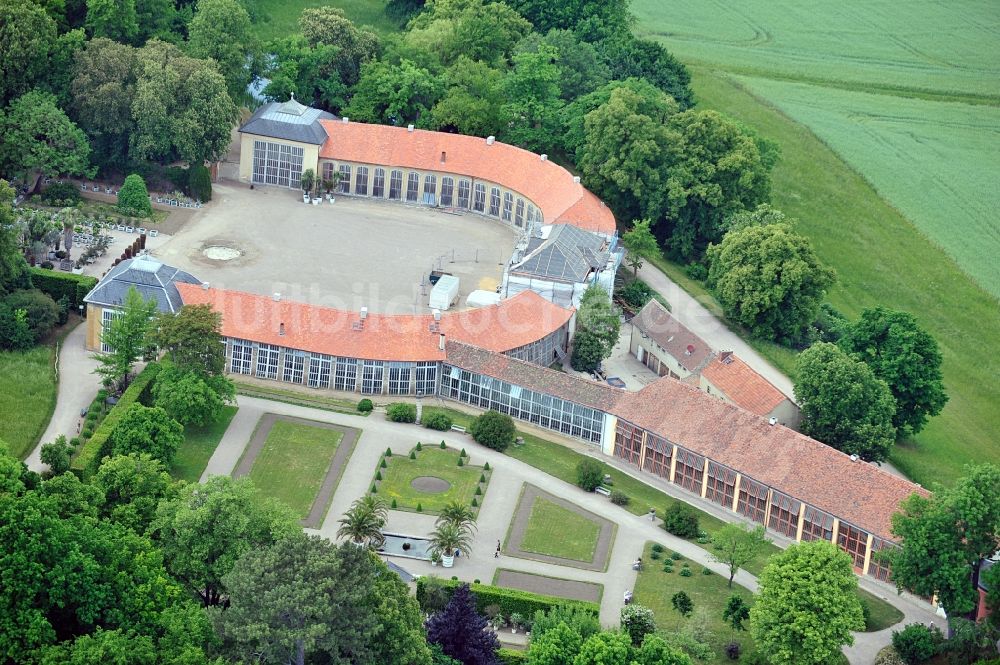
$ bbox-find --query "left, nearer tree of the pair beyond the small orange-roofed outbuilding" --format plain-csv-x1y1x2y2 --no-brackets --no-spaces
795,342,896,462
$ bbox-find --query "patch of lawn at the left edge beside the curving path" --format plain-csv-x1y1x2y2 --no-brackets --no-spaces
0,345,57,459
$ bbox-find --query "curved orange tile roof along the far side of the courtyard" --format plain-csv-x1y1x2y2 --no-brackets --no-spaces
319,120,615,236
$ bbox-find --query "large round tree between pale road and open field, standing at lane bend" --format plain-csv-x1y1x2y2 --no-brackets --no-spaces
707,224,836,343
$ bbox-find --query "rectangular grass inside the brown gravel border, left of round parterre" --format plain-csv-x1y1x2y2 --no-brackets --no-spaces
250,420,343,518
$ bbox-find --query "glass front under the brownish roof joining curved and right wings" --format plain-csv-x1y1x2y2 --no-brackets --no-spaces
440,364,604,443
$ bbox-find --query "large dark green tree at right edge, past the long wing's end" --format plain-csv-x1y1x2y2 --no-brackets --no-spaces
883,464,1000,616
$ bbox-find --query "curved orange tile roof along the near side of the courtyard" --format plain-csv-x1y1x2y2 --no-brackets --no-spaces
178,284,573,361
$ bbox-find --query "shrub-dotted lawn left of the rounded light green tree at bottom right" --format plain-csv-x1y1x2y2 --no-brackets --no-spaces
633,543,754,665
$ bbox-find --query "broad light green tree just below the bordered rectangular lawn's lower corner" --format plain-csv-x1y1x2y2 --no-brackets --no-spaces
151,476,301,607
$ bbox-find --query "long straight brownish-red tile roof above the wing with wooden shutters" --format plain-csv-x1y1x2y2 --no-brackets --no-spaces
614,377,926,540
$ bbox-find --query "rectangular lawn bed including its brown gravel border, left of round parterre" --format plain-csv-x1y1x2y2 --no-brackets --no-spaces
233,414,360,527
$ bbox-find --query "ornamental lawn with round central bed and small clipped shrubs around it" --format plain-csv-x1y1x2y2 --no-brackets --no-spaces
371,441,492,514
